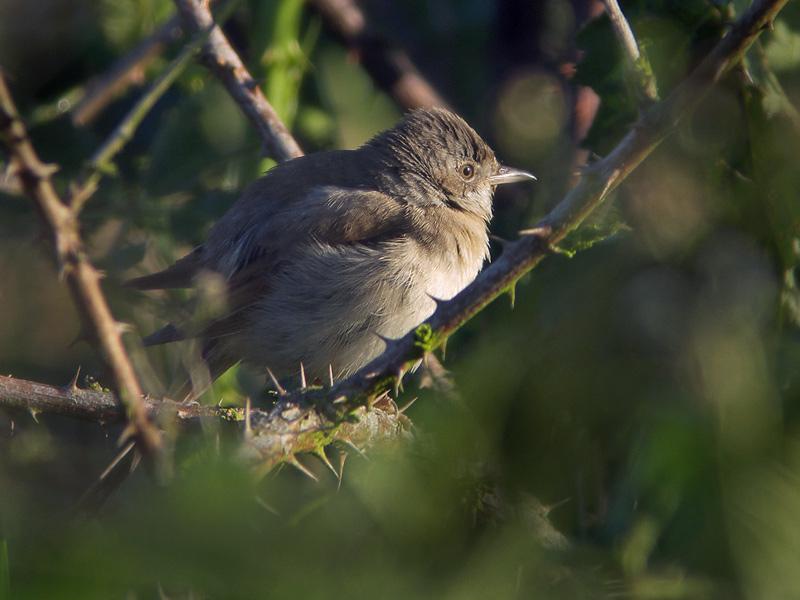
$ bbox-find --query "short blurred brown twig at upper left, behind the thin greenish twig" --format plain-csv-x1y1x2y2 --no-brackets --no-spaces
72,16,181,126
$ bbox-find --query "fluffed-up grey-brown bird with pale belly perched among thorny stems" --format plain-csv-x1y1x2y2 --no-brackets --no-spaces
128,108,536,394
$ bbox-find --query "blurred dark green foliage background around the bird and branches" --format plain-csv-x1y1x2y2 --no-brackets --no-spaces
0,0,800,598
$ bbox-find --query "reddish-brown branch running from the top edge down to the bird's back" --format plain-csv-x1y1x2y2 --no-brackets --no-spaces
175,0,303,162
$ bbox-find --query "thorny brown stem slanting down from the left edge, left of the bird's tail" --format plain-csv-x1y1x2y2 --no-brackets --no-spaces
0,73,161,456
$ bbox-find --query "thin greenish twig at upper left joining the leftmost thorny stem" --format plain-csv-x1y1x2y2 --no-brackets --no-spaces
70,1,242,214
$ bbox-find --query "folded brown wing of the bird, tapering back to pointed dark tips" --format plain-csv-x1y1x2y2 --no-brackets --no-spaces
138,186,408,344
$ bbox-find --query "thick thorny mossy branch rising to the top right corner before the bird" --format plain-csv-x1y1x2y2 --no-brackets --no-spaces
0,0,788,474
